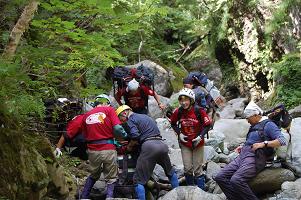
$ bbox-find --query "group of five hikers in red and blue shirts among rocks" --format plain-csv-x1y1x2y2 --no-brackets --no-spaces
55,74,286,200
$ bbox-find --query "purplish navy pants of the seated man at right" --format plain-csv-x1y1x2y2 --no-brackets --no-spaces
214,146,258,200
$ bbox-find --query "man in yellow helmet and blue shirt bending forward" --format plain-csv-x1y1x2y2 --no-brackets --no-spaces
116,105,179,200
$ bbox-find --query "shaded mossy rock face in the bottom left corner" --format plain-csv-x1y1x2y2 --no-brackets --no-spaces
0,128,72,199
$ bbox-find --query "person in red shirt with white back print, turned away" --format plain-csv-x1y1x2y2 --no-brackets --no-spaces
81,95,127,199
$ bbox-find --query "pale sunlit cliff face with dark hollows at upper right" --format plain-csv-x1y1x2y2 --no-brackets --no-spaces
215,0,301,102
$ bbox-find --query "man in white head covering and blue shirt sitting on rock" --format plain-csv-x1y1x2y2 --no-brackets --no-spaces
214,101,286,200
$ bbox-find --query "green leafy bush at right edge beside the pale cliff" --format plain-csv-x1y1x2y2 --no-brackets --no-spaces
273,54,301,108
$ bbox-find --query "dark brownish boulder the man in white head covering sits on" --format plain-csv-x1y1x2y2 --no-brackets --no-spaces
249,168,295,194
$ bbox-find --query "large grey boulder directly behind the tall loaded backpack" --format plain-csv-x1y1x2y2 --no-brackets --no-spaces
128,60,173,97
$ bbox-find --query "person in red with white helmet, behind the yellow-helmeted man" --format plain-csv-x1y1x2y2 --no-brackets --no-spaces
115,79,165,114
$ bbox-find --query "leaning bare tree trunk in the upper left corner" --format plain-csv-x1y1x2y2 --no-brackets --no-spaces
3,1,39,58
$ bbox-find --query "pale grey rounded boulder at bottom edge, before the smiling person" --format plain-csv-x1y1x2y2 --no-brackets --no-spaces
159,186,226,200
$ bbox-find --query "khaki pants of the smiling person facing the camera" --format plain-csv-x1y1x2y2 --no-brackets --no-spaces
180,144,204,177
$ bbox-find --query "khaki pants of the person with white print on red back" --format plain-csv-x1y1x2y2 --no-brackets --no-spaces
88,150,118,184
